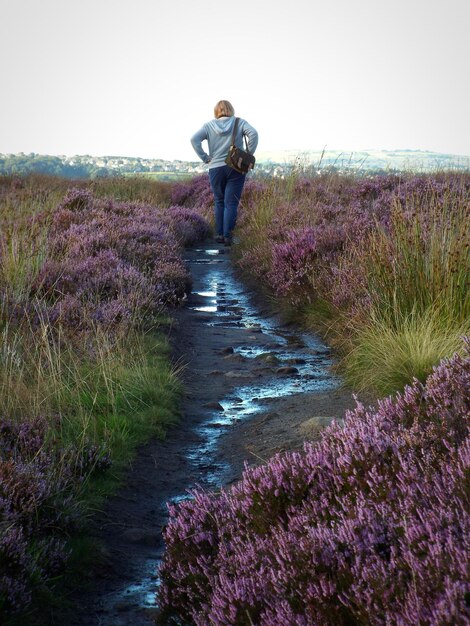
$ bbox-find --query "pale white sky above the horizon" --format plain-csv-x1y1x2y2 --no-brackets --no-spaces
0,0,470,160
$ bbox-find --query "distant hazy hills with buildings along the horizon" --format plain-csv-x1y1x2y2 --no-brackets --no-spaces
0,150,470,180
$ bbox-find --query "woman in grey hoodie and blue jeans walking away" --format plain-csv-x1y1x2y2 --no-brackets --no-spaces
191,100,258,246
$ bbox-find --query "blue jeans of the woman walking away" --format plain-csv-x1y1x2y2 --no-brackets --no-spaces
209,165,246,238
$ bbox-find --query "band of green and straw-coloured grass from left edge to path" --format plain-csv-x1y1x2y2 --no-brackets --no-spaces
0,321,179,448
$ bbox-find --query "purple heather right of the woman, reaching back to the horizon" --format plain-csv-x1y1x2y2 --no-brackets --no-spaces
237,175,470,307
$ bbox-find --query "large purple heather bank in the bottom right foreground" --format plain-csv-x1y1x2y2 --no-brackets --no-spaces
160,341,470,626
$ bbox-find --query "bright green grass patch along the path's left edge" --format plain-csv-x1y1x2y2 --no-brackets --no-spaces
62,332,180,460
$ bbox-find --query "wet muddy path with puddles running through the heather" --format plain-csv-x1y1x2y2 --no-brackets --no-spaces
50,244,354,626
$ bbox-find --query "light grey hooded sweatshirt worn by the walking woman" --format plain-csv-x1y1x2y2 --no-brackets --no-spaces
191,116,258,169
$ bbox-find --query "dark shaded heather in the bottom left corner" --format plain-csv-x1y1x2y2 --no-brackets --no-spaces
0,418,109,620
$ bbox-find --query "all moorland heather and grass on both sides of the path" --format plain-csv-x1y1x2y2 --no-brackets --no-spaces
0,171,470,626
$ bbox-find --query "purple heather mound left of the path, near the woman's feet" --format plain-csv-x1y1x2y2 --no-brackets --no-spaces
32,189,209,328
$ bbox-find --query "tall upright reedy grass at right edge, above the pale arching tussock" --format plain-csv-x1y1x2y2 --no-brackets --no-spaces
358,197,470,325
